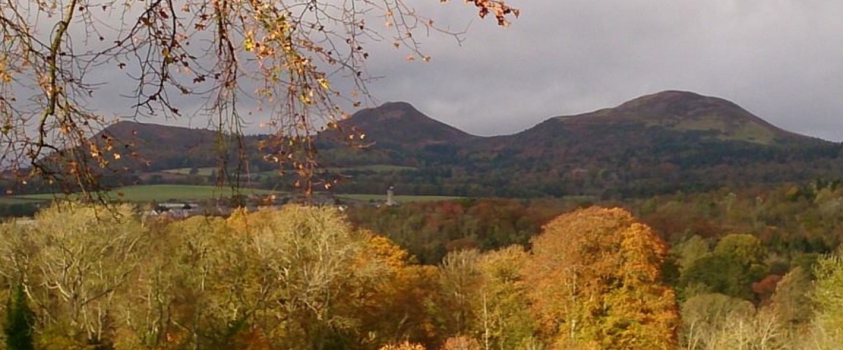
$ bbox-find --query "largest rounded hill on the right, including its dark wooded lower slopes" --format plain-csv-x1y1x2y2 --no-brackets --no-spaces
463,91,840,195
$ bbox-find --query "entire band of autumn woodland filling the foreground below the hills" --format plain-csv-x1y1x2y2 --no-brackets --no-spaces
0,181,843,350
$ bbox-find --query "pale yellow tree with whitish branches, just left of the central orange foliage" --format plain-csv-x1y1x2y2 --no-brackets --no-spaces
228,206,372,349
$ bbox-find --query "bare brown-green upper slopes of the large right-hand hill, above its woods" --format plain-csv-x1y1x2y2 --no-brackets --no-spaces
480,91,808,149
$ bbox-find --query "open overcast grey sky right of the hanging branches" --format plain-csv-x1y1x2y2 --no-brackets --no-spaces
354,0,843,141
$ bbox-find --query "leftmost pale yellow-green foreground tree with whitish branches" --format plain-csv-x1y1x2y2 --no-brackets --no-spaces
0,203,145,349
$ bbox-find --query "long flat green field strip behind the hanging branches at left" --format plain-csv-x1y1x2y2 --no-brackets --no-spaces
16,185,273,202
